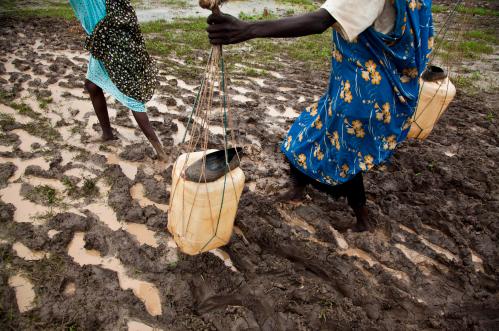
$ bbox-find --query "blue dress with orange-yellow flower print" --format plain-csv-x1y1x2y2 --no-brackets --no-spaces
281,0,433,185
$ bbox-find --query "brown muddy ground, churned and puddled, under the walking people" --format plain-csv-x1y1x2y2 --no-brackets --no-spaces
0,4,499,330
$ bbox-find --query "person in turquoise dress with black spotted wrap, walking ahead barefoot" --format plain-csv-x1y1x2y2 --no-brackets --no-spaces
69,0,166,159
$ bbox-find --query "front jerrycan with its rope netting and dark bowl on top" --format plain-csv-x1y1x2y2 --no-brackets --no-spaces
168,0,245,255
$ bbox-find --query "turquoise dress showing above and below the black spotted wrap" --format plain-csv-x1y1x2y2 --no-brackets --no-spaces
69,0,146,112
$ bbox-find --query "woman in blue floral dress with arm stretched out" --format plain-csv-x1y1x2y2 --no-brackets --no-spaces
207,0,433,231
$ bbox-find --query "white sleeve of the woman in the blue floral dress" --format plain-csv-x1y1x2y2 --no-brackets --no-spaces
321,0,386,41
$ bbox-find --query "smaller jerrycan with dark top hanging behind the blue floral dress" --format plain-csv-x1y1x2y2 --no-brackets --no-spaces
407,66,456,140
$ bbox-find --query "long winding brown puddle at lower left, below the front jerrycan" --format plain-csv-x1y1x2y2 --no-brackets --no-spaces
68,232,162,316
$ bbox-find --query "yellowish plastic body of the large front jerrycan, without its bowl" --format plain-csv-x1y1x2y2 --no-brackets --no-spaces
168,150,245,255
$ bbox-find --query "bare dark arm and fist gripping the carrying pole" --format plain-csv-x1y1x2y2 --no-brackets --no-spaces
207,9,335,45
